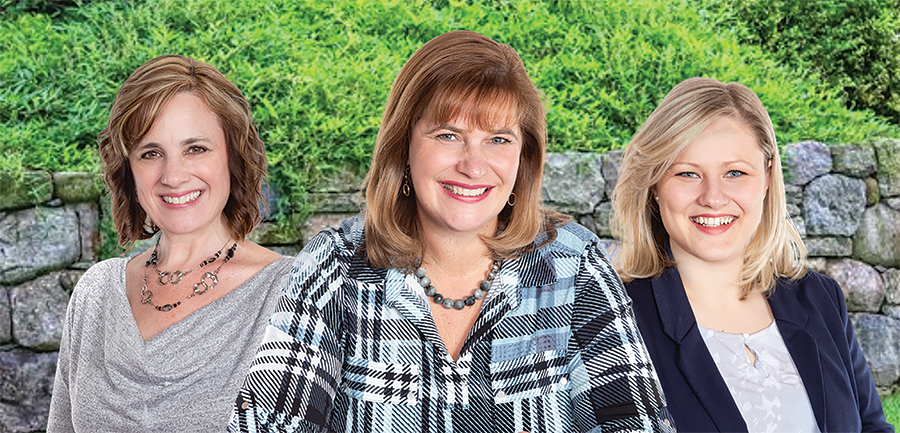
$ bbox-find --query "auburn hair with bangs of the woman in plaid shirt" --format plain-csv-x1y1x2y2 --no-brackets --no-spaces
364,30,566,269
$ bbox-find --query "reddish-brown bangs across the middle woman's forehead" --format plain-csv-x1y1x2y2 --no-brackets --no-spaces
422,86,522,131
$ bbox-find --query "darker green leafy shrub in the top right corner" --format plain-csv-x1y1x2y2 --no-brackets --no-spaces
720,0,900,123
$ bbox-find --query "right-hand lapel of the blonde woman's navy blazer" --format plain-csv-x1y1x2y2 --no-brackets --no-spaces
769,281,826,431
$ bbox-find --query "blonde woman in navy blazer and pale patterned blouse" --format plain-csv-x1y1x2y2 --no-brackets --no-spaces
613,78,893,432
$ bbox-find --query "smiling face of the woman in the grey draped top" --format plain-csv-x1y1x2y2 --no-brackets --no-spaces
129,93,231,235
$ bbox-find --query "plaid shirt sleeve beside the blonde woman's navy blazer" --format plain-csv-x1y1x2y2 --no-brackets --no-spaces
568,239,675,432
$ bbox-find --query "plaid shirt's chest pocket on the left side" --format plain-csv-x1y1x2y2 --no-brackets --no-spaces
342,357,421,405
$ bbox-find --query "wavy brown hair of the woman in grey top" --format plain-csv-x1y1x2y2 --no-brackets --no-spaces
97,55,268,248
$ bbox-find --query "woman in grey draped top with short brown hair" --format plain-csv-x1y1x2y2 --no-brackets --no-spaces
47,56,292,432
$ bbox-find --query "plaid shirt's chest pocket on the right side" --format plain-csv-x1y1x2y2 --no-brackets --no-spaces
491,350,569,404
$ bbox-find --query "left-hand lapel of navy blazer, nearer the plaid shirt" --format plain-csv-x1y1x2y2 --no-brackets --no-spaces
651,268,747,431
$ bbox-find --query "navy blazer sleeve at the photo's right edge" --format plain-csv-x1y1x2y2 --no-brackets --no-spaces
826,278,894,432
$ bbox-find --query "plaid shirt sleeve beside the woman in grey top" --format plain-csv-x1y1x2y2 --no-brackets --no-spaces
228,232,343,432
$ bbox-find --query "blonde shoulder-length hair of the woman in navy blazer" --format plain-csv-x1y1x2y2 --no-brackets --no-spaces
611,78,806,297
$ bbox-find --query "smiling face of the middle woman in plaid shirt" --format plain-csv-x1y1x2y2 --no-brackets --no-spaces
409,106,522,235
